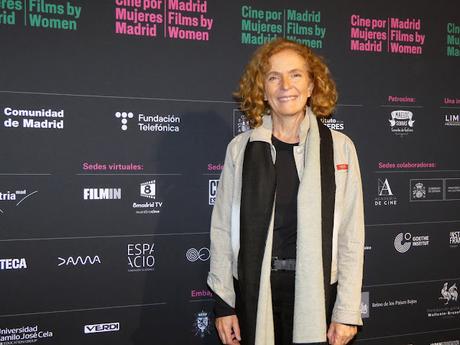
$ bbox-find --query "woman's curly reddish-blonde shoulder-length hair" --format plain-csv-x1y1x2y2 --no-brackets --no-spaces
234,38,337,128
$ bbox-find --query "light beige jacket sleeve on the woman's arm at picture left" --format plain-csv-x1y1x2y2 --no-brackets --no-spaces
207,143,235,316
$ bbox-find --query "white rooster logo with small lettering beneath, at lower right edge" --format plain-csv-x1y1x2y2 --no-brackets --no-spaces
426,282,460,319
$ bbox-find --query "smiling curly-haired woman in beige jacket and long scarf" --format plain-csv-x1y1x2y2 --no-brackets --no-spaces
208,39,364,345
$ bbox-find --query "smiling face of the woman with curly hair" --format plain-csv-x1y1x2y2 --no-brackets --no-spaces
264,49,313,116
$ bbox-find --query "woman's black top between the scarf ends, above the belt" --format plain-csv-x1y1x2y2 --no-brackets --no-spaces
272,136,299,259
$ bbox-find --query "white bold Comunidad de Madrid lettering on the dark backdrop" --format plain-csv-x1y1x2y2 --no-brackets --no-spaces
3,107,64,130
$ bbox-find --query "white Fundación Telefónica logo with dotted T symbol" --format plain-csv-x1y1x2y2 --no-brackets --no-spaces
115,111,181,133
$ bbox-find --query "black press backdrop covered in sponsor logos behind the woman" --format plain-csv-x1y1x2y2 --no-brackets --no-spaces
0,0,460,345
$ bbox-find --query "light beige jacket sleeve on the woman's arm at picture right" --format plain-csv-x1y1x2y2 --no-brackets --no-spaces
332,138,364,325
